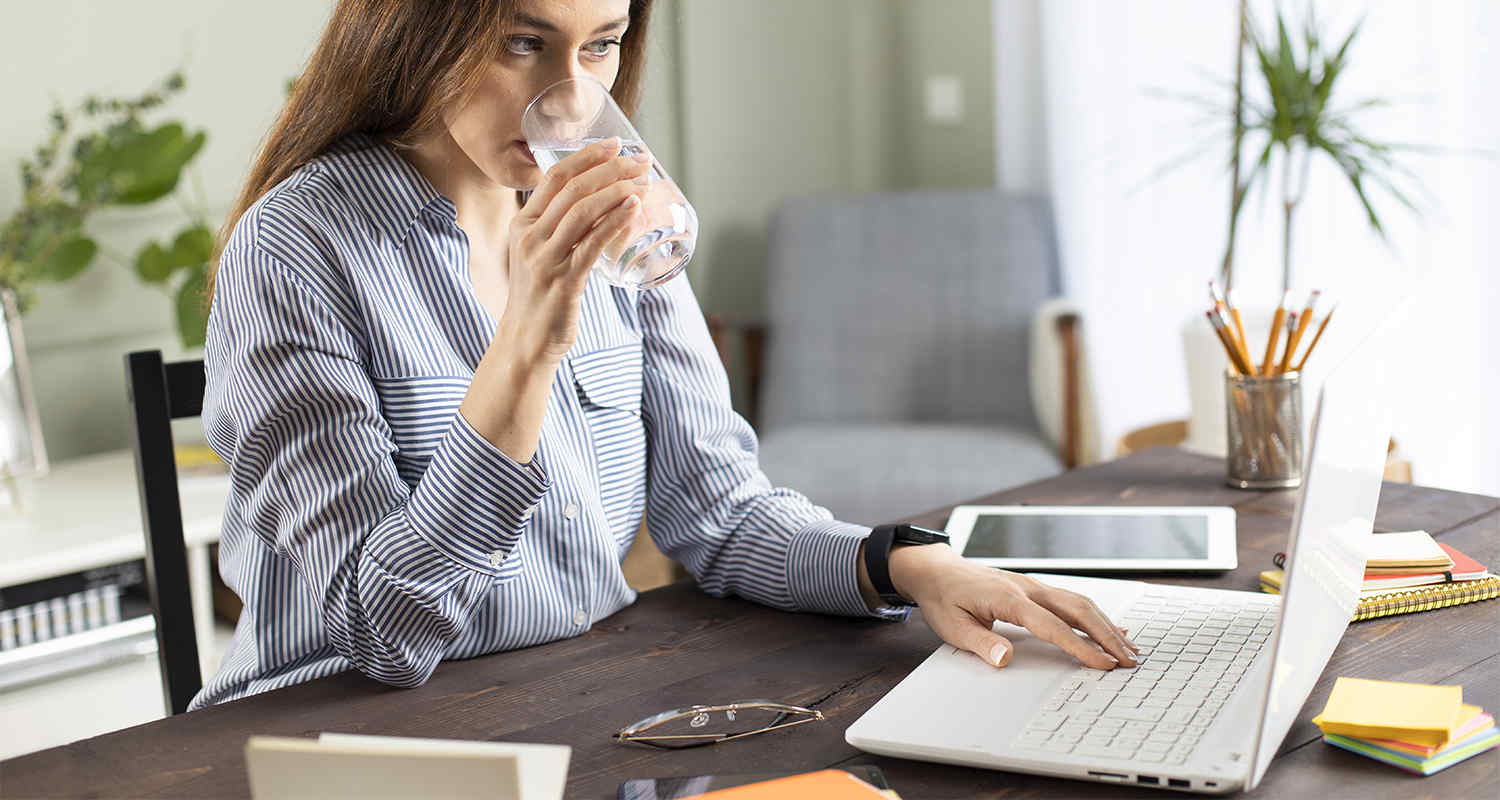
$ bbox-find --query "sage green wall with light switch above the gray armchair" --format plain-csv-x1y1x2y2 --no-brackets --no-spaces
668,0,995,317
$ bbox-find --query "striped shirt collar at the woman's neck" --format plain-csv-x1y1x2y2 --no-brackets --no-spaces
329,134,459,245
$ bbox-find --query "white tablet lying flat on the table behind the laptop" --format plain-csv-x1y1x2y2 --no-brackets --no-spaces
947,506,1239,572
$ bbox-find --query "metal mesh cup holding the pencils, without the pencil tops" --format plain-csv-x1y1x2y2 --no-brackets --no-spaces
1224,372,1302,489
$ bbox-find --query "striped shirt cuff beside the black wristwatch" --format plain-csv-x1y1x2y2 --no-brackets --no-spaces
786,519,911,620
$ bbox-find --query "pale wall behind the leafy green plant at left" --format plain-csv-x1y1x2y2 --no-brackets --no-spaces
0,0,330,461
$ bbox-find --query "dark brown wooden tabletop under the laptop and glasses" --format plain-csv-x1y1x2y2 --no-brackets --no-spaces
0,449,1500,800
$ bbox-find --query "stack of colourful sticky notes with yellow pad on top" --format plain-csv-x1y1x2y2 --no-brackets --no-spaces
1313,678,1500,774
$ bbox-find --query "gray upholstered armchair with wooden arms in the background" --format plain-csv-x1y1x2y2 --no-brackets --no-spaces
710,191,1082,524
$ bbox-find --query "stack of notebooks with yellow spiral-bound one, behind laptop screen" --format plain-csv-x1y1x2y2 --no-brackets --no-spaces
1260,530,1500,620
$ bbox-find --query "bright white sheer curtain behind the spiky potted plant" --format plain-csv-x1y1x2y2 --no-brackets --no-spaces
995,0,1500,494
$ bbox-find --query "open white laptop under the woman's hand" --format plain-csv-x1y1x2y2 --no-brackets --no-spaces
845,326,1391,794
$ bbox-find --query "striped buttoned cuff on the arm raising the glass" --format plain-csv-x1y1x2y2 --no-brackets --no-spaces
407,413,552,576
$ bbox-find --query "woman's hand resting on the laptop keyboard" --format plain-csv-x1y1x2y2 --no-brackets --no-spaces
890,545,1137,669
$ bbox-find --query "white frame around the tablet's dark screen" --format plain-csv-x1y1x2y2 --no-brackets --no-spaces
945,506,1239,572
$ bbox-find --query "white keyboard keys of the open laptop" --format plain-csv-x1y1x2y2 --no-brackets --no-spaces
1016,591,1278,764
